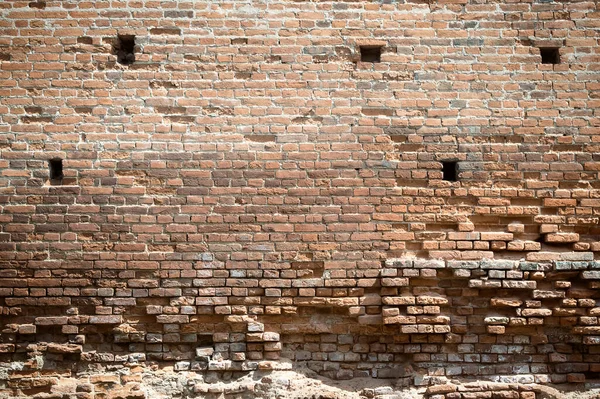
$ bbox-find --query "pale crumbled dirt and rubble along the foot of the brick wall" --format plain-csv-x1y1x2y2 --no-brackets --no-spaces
0,362,600,399
